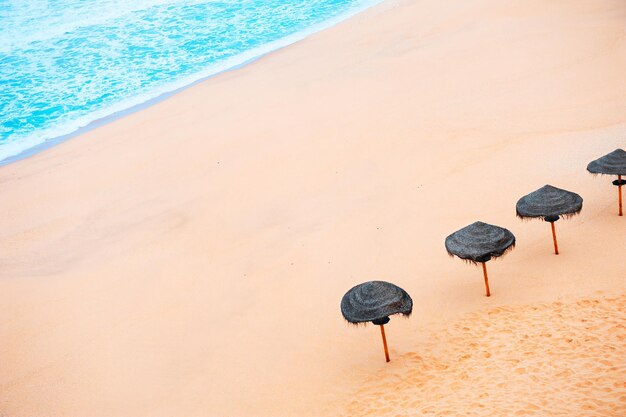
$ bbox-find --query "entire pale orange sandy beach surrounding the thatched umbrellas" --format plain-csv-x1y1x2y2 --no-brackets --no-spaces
0,0,626,417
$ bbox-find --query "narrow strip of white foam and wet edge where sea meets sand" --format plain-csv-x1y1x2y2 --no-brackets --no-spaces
0,0,389,168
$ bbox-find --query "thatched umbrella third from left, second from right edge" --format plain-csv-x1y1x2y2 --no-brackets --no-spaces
515,185,583,255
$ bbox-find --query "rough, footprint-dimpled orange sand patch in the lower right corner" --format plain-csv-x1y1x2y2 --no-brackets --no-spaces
345,295,626,416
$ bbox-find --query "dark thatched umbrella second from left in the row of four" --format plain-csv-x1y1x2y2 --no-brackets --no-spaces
446,222,515,297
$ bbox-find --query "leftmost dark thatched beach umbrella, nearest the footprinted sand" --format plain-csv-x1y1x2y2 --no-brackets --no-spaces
341,281,413,362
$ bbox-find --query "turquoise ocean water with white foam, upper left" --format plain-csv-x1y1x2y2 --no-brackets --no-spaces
0,0,380,161
